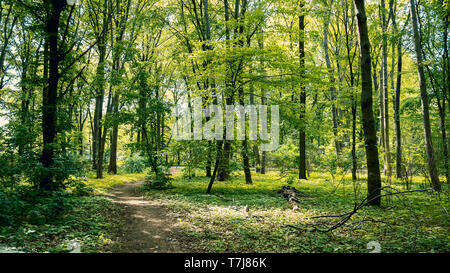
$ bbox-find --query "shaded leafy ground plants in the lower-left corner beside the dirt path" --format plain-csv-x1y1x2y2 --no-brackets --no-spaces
0,196,120,252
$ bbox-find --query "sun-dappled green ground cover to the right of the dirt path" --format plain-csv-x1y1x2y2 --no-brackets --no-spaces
142,170,450,252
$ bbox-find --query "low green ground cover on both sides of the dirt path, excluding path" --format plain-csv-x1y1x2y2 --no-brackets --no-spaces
0,169,450,252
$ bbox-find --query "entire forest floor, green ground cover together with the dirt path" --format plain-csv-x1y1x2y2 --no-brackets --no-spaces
0,168,450,253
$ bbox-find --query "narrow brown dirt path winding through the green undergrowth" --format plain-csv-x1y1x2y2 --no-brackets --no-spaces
110,181,186,253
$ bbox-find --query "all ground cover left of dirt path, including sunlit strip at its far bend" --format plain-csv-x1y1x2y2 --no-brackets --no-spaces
0,174,145,252
